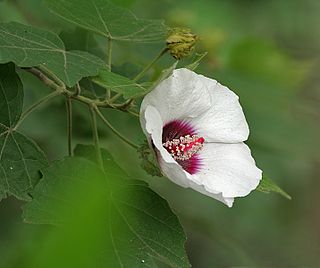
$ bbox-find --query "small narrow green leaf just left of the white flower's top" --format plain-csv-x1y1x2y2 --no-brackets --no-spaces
92,69,146,99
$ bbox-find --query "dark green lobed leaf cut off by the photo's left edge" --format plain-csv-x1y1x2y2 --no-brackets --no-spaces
0,64,47,200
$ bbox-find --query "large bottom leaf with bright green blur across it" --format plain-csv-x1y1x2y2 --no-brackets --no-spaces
23,156,190,267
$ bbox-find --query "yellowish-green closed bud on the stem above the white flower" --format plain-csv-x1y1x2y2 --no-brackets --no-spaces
166,28,198,60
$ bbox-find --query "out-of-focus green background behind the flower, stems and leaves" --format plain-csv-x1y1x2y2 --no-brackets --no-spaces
0,0,320,268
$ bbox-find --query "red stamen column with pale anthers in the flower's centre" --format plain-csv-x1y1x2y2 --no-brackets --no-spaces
162,135,204,161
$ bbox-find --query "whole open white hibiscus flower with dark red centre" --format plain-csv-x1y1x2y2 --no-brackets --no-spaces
140,69,262,207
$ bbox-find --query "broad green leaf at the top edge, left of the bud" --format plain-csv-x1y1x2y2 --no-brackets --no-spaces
45,0,167,42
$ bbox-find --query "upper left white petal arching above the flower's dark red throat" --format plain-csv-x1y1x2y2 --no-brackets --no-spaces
140,69,211,124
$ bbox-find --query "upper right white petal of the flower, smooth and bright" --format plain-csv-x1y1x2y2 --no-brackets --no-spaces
191,76,249,143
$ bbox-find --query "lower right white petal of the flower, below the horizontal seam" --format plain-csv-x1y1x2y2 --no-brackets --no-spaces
192,143,262,198
